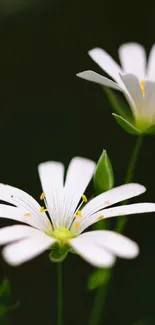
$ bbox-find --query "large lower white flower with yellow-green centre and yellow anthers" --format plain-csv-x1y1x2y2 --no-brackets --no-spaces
0,157,155,267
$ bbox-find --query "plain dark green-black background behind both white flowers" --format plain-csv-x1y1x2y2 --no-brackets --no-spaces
0,0,155,325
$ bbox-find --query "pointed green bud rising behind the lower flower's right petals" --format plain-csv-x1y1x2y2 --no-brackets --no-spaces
93,150,114,194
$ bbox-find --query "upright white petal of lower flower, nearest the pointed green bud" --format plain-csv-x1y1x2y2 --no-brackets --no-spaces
63,157,96,227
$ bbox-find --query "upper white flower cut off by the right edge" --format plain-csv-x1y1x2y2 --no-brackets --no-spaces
77,43,155,134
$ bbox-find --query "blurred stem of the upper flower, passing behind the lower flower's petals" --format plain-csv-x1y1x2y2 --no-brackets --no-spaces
89,136,143,325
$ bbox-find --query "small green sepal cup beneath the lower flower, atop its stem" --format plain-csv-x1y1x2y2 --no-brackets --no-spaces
49,243,69,263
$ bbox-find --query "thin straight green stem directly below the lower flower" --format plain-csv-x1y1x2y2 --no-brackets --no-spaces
58,262,63,325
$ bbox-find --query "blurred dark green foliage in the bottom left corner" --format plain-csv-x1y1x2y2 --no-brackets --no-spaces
0,279,19,325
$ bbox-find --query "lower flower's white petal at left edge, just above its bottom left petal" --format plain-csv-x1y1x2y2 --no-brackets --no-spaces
0,225,40,245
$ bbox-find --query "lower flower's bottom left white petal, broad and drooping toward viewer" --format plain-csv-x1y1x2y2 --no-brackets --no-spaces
2,233,56,266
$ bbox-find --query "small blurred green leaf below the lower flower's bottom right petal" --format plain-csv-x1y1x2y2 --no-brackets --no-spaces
88,269,111,290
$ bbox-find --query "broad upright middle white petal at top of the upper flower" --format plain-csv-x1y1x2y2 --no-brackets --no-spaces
118,43,146,81
